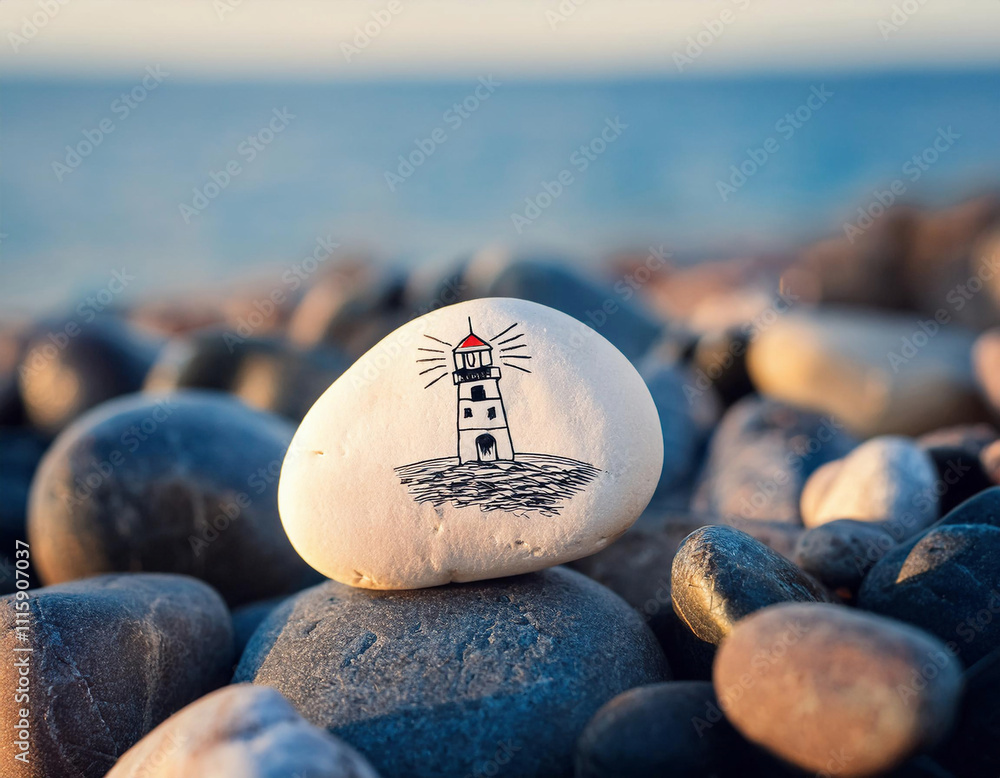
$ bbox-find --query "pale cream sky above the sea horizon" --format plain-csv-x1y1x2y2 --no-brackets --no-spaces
0,0,1000,79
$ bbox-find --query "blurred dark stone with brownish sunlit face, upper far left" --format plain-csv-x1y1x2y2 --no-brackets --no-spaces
18,316,157,435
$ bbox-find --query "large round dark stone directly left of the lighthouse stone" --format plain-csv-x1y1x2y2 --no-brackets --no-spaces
28,391,316,605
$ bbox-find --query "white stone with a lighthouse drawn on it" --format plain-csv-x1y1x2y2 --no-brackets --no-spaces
278,298,663,589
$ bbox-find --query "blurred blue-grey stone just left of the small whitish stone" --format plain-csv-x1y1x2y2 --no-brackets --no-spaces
692,397,854,524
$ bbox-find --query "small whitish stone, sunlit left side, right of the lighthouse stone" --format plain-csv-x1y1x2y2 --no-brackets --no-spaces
801,435,938,537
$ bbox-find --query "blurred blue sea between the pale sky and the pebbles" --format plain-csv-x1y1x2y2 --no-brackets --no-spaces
0,69,1000,312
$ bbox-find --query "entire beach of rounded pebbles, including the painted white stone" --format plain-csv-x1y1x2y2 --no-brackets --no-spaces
0,189,1000,778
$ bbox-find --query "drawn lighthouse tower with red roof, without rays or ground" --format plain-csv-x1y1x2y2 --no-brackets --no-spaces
451,319,514,464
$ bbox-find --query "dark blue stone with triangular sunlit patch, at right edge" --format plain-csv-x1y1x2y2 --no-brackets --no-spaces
858,524,1000,666
